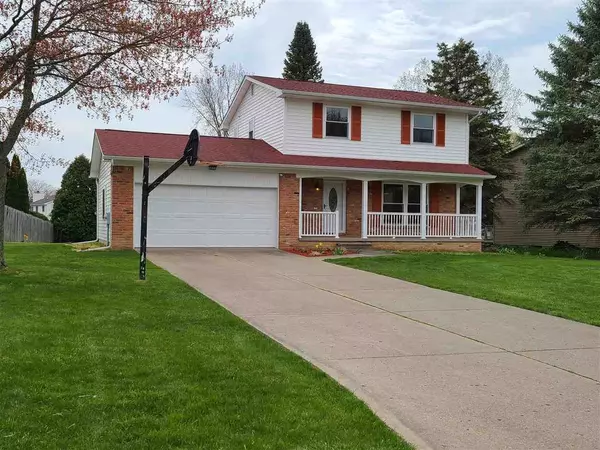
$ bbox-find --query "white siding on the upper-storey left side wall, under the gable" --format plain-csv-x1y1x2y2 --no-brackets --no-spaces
229,84,285,150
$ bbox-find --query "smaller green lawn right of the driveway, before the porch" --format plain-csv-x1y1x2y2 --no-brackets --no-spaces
330,253,600,326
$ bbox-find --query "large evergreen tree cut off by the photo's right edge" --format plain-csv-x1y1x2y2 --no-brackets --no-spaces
518,0,600,233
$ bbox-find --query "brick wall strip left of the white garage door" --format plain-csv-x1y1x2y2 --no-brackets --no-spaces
110,166,133,249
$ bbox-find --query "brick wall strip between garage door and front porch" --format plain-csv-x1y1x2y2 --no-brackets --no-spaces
279,173,300,249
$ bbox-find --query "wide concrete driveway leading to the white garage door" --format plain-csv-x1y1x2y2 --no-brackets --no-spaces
149,250,600,450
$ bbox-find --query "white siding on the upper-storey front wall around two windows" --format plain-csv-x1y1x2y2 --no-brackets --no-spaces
279,98,469,164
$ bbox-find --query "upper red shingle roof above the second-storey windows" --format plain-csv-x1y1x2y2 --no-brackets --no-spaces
250,75,481,109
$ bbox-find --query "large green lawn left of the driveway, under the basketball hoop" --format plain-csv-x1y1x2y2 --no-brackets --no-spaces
0,244,410,450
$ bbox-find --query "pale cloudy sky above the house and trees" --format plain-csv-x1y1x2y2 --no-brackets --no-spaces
29,0,580,187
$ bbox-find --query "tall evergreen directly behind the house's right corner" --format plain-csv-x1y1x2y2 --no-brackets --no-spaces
425,39,513,224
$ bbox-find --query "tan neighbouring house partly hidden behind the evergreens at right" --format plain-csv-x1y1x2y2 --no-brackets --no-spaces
494,144,600,248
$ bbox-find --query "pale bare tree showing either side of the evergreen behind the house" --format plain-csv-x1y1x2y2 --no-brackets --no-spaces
394,51,523,126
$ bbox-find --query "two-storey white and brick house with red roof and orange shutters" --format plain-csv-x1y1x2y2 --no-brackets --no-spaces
91,76,493,251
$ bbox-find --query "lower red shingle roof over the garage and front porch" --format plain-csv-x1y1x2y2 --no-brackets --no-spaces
96,130,487,176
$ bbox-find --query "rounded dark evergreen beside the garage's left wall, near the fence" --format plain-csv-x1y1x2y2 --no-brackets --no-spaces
52,155,96,242
